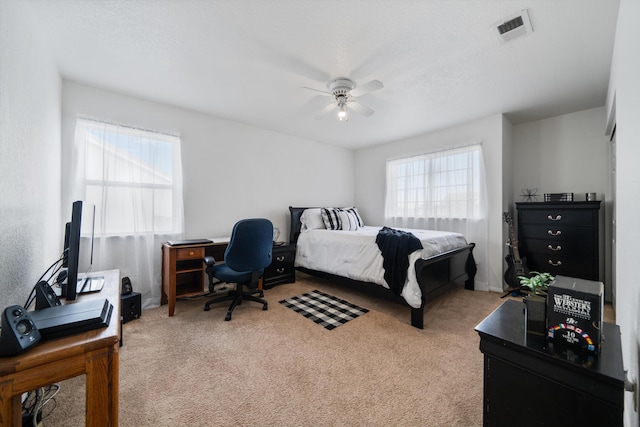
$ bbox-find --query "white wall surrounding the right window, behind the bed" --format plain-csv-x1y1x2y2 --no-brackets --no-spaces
355,114,510,292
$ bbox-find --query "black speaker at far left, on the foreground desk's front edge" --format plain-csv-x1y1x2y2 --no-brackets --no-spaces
0,305,41,356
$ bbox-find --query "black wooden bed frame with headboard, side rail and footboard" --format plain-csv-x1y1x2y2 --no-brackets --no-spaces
289,206,477,329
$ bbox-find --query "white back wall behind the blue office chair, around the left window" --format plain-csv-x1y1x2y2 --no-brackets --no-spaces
62,80,354,244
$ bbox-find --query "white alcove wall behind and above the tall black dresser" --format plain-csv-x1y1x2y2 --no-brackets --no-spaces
513,107,611,288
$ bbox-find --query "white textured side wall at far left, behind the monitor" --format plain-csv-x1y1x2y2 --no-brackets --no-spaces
0,2,64,311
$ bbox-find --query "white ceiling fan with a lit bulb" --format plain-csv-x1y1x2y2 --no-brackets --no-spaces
304,77,384,122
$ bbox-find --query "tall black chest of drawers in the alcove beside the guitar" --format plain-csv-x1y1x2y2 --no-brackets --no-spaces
516,201,600,281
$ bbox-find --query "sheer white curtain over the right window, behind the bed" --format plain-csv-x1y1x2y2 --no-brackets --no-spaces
385,144,488,286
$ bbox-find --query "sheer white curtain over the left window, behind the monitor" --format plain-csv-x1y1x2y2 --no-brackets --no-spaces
73,118,183,308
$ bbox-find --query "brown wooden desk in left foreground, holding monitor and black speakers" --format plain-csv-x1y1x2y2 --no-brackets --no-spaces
0,270,120,427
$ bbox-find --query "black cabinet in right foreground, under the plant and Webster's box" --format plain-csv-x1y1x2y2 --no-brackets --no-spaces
475,300,624,426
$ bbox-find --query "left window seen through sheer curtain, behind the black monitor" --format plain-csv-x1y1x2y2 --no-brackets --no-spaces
76,119,182,236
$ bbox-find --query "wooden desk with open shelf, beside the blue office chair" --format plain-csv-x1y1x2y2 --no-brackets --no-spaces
160,242,229,316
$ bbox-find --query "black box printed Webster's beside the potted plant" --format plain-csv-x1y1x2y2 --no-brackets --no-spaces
547,276,604,353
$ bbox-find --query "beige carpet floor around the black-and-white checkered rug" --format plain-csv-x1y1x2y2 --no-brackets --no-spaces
43,273,516,427
